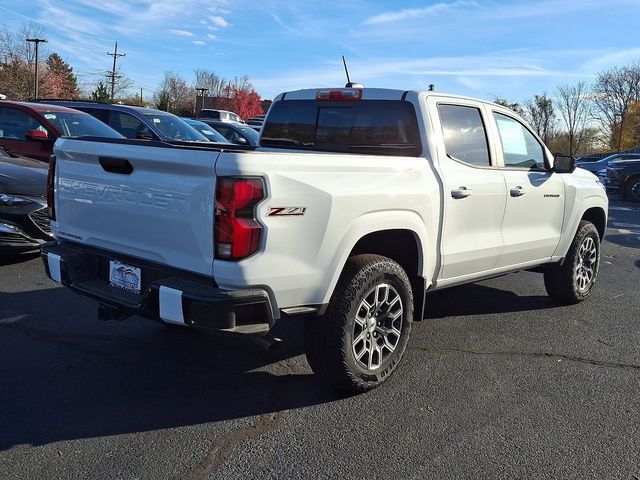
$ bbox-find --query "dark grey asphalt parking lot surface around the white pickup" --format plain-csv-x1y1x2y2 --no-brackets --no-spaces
0,200,640,480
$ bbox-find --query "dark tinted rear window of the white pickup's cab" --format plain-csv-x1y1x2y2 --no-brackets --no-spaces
260,100,422,156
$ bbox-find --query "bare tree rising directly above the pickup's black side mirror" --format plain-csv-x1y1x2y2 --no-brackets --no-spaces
555,82,592,155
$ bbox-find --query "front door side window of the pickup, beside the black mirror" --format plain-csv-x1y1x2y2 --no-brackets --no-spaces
493,112,545,170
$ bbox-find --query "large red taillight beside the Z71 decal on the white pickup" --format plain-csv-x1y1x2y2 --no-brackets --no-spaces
214,177,264,260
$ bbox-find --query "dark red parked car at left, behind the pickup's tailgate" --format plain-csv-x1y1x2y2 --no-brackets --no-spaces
0,100,123,162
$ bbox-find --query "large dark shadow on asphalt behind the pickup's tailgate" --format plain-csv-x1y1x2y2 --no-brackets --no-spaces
0,288,341,450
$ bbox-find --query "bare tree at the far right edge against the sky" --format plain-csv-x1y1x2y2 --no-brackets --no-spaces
593,62,640,151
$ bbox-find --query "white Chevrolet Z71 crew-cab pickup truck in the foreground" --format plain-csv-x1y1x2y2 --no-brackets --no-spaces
42,88,608,392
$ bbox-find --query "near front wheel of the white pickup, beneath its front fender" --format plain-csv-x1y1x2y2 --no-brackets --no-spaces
544,220,600,304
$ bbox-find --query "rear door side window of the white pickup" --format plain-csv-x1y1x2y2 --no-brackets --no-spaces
438,104,491,167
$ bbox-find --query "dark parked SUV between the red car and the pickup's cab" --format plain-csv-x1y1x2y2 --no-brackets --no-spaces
32,100,209,142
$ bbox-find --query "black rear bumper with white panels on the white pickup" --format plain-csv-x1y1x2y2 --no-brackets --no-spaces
41,242,275,335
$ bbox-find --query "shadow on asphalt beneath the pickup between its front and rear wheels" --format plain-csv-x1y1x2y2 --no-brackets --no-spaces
426,283,558,318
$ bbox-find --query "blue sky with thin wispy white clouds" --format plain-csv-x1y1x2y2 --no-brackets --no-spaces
0,0,640,101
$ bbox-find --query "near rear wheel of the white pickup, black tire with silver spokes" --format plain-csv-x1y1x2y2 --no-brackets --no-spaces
304,255,413,393
